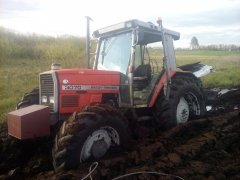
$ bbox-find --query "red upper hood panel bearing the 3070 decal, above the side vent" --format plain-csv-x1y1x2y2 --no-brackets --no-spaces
55,69,120,94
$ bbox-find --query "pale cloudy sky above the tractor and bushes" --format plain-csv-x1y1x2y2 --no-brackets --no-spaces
0,0,240,47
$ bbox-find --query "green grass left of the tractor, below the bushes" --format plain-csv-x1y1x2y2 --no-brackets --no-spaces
0,57,85,122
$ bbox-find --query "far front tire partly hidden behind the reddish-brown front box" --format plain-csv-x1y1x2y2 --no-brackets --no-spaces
16,87,39,109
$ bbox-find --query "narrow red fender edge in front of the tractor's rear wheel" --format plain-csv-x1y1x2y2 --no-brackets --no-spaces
149,71,176,107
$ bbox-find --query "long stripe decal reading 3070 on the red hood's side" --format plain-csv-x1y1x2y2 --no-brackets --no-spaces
62,85,119,91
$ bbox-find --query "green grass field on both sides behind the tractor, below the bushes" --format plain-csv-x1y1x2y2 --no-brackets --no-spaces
0,50,240,122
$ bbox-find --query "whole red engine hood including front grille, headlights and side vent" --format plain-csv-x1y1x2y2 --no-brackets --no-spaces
40,68,120,114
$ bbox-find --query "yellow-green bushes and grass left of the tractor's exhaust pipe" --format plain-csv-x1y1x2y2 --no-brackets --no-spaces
0,27,89,122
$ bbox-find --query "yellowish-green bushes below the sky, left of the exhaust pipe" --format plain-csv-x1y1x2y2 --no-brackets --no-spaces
0,27,85,59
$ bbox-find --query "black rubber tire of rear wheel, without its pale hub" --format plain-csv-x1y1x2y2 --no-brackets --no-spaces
153,76,206,130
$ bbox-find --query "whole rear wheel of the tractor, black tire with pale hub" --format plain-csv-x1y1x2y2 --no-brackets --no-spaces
154,77,206,130
